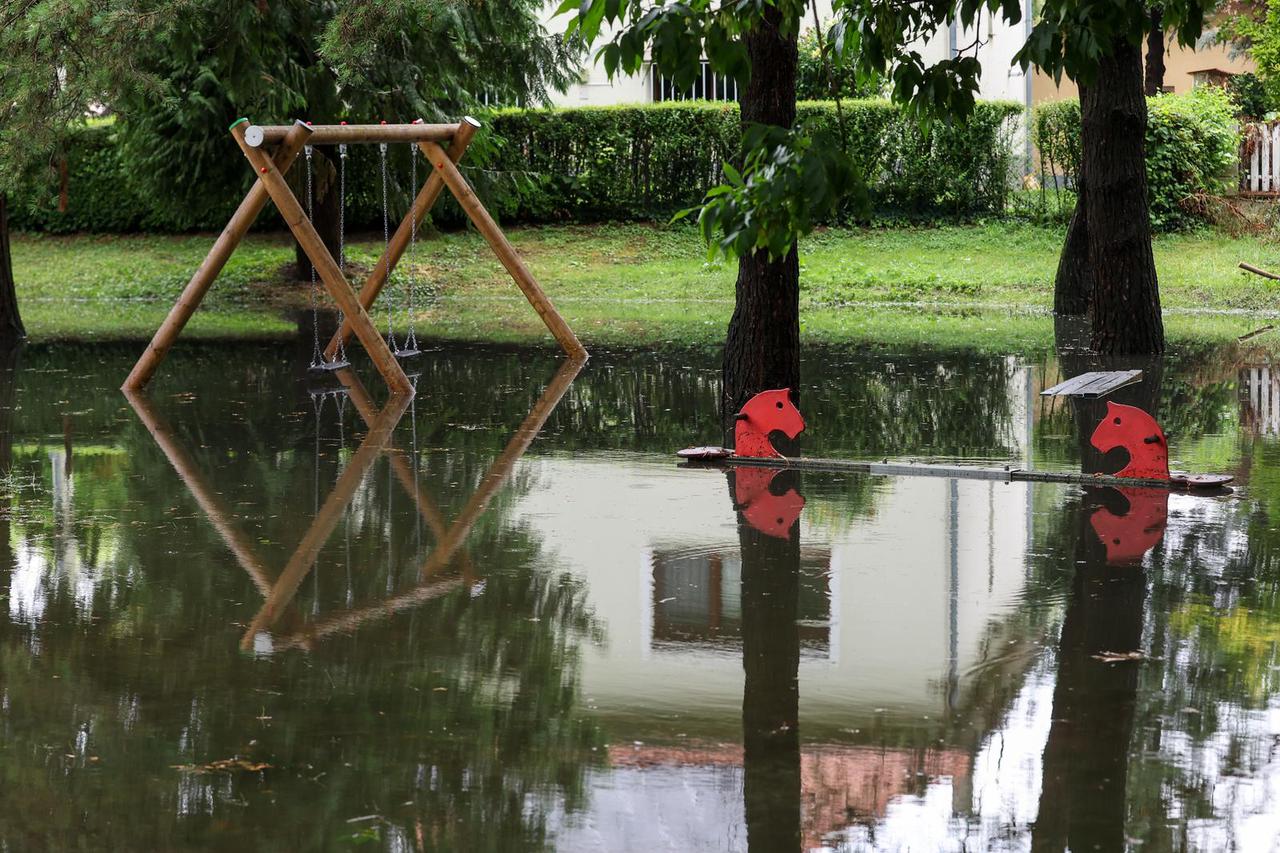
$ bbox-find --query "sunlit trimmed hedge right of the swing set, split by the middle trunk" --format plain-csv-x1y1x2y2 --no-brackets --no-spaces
489,100,1021,222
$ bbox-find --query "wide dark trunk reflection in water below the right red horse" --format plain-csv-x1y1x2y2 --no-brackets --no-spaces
1032,489,1147,850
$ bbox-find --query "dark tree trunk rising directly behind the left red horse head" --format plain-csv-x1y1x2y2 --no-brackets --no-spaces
721,6,800,443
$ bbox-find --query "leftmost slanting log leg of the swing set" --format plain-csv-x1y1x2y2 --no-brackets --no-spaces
122,122,311,391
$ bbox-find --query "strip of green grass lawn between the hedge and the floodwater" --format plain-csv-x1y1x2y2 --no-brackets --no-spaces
13,223,1280,351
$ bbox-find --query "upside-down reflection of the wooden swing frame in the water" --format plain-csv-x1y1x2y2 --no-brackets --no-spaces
125,359,584,651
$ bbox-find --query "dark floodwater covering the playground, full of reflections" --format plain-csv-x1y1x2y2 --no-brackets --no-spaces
0,335,1280,853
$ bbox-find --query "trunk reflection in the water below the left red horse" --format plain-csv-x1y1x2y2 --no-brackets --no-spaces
739,471,801,853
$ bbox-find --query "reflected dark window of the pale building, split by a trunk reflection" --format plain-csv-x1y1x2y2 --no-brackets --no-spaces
652,544,831,657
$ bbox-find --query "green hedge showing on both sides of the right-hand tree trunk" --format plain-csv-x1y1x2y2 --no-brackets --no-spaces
1032,86,1240,231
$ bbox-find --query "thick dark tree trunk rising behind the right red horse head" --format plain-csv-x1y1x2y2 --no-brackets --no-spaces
1080,40,1165,355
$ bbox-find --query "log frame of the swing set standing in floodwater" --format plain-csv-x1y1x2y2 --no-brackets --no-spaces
123,117,586,394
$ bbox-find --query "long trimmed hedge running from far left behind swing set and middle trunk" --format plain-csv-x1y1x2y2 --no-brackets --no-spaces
12,100,1021,233
